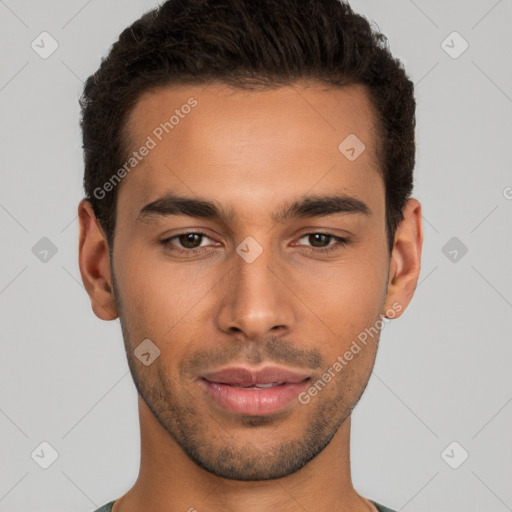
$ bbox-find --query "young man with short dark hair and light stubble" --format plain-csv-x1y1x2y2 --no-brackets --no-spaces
78,0,423,512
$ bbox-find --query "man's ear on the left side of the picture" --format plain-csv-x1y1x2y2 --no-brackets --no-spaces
78,199,118,320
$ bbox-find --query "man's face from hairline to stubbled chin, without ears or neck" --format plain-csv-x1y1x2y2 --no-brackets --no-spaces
79,85,416,480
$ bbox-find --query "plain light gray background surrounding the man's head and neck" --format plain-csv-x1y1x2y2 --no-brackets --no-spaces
0,0,512,512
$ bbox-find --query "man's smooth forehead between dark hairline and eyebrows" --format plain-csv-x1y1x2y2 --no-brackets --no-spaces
118,84,383,222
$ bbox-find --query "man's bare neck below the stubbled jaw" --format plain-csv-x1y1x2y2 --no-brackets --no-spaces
112,396,375,512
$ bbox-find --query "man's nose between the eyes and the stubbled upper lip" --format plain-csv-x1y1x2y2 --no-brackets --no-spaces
217,243,295,340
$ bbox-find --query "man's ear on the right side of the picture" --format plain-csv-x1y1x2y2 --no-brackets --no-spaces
385,199,423,318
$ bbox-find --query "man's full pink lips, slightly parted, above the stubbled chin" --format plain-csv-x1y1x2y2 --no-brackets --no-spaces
199,366,310,415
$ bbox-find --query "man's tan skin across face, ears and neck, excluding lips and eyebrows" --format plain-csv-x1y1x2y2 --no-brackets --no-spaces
78,83,423,512
